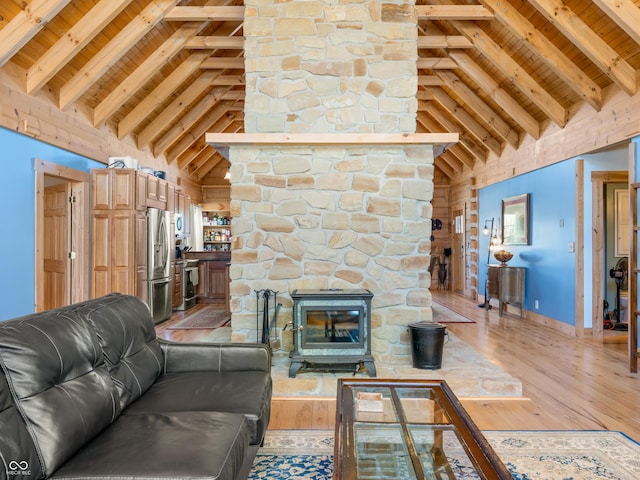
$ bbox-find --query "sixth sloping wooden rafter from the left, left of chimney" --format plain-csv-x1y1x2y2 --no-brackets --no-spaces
138,71,222,148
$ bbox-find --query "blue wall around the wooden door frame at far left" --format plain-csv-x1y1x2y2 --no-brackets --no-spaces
0,128,104,320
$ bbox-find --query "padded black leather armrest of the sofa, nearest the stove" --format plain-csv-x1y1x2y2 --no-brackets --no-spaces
158,338,271,373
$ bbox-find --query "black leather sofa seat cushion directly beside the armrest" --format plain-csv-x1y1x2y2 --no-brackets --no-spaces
123,371,272,445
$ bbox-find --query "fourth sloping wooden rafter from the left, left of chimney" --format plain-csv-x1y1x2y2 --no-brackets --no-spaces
93,23,207,127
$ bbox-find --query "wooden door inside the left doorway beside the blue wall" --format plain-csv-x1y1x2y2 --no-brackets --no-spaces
43,182,72,310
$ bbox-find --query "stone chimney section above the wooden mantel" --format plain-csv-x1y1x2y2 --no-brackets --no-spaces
244,0,418,133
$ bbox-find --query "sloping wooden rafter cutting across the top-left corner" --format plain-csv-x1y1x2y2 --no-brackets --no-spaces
0,0,71,67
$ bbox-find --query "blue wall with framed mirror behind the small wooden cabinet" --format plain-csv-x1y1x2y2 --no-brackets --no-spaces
478,160,576,325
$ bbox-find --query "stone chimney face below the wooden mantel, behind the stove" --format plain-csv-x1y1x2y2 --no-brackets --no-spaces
230,146,433,360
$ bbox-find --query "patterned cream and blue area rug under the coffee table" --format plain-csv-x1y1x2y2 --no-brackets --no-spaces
249,430,640,480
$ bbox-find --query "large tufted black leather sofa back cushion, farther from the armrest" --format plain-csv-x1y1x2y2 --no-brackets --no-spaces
0,306,120,476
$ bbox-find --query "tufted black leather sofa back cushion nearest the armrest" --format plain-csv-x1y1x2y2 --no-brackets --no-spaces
82,293,163,409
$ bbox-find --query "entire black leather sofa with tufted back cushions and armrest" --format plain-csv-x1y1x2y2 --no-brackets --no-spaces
0,294,272,480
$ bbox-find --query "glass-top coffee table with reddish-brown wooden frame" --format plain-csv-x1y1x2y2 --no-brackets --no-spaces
333,378,513,480
